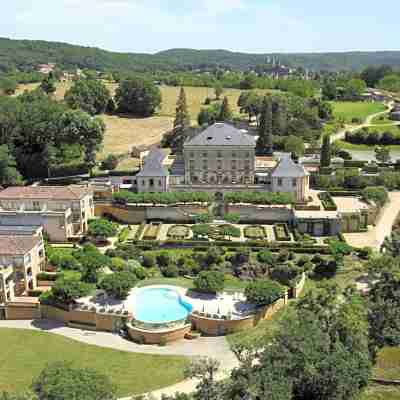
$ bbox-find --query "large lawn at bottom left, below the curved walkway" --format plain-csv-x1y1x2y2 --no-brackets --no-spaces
0,328,188,397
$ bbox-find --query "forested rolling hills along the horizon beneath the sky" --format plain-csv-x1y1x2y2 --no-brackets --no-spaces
0,38,400,71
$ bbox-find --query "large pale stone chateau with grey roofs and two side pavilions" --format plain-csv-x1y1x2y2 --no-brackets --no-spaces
136,123,309,202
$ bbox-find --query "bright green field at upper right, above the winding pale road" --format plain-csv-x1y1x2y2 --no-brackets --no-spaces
331,101,386,124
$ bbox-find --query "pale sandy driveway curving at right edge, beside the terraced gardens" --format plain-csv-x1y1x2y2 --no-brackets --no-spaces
344,192,400,251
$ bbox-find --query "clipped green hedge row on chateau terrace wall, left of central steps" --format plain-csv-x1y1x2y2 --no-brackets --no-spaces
113,190,212,204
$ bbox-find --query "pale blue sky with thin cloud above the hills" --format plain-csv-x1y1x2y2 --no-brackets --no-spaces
0,0,400,53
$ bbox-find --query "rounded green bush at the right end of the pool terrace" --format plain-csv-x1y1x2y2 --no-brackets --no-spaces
244,280,285,306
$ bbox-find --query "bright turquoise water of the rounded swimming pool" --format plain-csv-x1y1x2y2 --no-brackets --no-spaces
134,288,192,324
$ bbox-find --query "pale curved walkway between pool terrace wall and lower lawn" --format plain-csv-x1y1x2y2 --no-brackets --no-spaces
0,320,238,400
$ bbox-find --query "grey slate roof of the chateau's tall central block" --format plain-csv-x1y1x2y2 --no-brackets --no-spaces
184,123,256,147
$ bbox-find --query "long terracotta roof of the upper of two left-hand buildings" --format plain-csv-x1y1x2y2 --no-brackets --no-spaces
0,185,91,200
